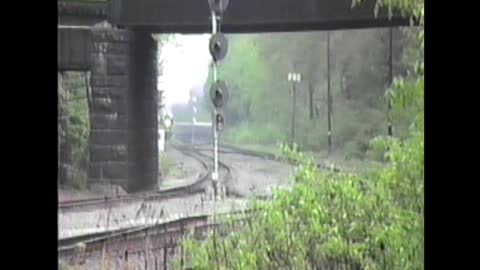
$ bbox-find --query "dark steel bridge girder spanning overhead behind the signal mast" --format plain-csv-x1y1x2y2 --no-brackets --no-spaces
107,0,409,33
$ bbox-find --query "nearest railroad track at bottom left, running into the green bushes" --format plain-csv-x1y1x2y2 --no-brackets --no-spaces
57,210,255,270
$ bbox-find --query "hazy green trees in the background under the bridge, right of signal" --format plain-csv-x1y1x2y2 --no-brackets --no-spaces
213,26,420,160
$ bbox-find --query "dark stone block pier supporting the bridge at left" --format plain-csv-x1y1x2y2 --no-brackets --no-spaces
88,24,158,192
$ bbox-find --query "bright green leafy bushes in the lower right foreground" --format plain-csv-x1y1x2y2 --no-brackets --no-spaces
174,122,424,270
